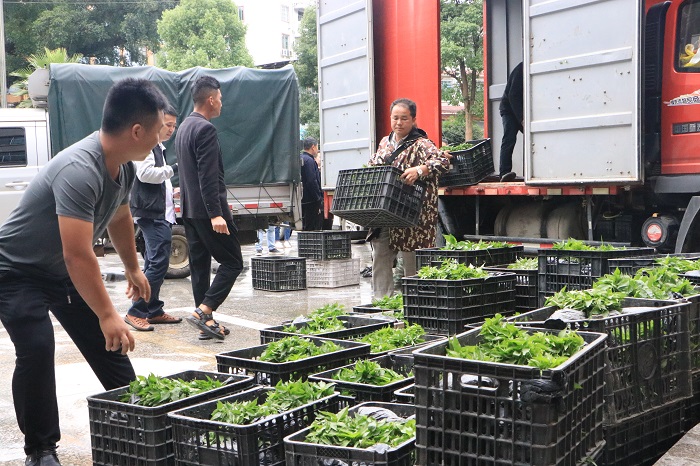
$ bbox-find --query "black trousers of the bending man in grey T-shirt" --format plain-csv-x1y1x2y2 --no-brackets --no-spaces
0,272,136,454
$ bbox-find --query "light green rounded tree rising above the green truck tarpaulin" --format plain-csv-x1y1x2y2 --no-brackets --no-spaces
158,0,253,71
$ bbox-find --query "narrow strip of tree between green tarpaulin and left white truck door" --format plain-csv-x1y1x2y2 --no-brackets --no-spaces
294,6,321,139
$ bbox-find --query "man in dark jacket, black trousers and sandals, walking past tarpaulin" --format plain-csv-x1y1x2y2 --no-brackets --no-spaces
175,76,243,340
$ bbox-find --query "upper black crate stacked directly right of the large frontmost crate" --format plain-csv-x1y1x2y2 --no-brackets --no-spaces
509,298,692,425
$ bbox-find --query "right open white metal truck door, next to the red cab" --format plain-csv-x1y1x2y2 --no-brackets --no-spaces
524,0,644,184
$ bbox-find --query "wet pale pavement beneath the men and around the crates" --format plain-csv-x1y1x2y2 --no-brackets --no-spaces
0,235,378,466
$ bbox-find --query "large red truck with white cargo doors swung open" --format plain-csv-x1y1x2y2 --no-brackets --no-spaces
318,0,700,252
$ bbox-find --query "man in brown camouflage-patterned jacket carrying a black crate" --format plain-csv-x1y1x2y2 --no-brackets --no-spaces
369,99,450,299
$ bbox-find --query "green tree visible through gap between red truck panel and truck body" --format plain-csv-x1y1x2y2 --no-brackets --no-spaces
440,0,484,140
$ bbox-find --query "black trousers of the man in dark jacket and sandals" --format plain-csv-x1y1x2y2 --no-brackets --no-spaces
183,218,243,310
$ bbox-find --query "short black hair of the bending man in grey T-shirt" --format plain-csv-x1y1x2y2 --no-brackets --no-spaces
101,78,168,134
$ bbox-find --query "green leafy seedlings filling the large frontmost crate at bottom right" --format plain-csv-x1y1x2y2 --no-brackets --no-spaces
446,314,585,370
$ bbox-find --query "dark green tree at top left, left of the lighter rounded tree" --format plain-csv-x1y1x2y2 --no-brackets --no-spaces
22,0,178,66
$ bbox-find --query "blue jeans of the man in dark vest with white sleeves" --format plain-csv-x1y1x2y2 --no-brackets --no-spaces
127,218,173,319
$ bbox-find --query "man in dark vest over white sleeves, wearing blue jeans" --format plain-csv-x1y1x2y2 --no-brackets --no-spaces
124,105,182,332
